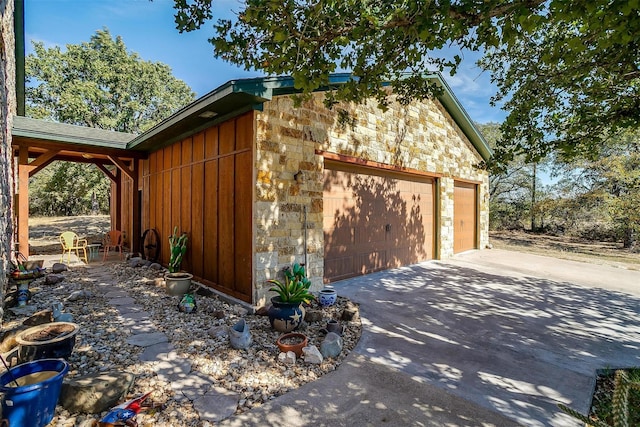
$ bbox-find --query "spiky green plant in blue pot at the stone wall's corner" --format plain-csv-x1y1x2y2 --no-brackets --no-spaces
267,264,313,332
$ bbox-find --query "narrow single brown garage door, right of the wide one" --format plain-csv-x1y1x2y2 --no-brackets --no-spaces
453,182,478,254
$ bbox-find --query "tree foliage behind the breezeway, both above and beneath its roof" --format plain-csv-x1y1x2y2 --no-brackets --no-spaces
25,29,195,215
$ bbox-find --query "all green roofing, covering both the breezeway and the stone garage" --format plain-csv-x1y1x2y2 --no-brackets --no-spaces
12,73,492,160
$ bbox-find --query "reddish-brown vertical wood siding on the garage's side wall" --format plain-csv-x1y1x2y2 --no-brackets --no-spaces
142,112,254,302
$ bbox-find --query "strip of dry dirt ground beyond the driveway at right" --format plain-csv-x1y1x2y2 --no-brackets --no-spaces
489,231,640,270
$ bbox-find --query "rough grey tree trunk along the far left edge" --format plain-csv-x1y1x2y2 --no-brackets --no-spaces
0,0,16,324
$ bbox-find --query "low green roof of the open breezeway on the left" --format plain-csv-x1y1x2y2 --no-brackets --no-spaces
11,116,136,150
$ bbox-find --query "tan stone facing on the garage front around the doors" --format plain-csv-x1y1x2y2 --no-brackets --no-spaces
255,93,489,304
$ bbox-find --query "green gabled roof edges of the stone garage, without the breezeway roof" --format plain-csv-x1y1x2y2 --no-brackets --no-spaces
127,73,492,160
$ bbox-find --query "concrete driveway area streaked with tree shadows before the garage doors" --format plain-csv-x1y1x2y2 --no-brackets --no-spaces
336,262,640,426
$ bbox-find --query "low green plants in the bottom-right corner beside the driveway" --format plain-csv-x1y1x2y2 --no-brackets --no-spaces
558,369,640,427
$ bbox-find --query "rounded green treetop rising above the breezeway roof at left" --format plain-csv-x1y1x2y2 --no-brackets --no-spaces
25,29,195,133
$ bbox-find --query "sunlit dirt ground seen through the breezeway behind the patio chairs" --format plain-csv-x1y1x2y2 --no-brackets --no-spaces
29,215,111,255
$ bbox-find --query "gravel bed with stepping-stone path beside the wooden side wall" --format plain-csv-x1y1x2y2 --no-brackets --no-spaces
3,262,361,427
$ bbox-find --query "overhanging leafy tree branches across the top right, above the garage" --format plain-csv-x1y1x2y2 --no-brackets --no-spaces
174,0,640,161
